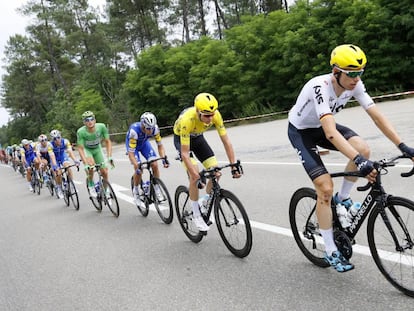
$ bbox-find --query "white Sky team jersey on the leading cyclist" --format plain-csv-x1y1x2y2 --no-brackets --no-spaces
289,74,375,130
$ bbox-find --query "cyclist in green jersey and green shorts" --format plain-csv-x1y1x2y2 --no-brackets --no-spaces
77,111,114,196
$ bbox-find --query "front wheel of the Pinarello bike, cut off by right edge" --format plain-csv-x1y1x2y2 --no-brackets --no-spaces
367,196,414,297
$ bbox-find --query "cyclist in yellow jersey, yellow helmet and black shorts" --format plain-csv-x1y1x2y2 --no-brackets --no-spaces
174,93,241,231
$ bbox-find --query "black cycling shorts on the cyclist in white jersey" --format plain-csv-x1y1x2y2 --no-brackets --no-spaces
288,123,358,180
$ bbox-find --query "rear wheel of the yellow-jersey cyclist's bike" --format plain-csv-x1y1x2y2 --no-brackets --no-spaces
174,185,204,243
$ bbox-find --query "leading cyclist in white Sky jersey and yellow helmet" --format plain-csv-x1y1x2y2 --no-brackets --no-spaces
288,44,414,272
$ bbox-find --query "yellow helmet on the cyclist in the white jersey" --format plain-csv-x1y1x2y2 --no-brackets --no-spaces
330,44,367,70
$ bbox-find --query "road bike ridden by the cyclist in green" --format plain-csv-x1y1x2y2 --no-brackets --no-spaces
86,163,119,217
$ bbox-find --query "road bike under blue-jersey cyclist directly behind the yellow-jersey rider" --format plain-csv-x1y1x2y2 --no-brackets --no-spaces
131,157,174,224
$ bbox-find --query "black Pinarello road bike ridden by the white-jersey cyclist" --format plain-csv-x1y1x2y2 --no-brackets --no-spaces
289,155,414,297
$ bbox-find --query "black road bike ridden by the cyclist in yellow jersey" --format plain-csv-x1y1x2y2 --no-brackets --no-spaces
175,161,253,258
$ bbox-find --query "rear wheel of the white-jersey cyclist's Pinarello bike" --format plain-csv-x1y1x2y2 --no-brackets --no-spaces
289,187,329,268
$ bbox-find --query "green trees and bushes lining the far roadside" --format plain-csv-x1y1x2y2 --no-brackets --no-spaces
0,0,414,143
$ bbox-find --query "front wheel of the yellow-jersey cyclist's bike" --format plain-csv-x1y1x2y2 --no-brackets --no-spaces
214,189,253,258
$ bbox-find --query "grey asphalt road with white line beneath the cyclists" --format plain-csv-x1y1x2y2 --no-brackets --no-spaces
0,99,414,311
